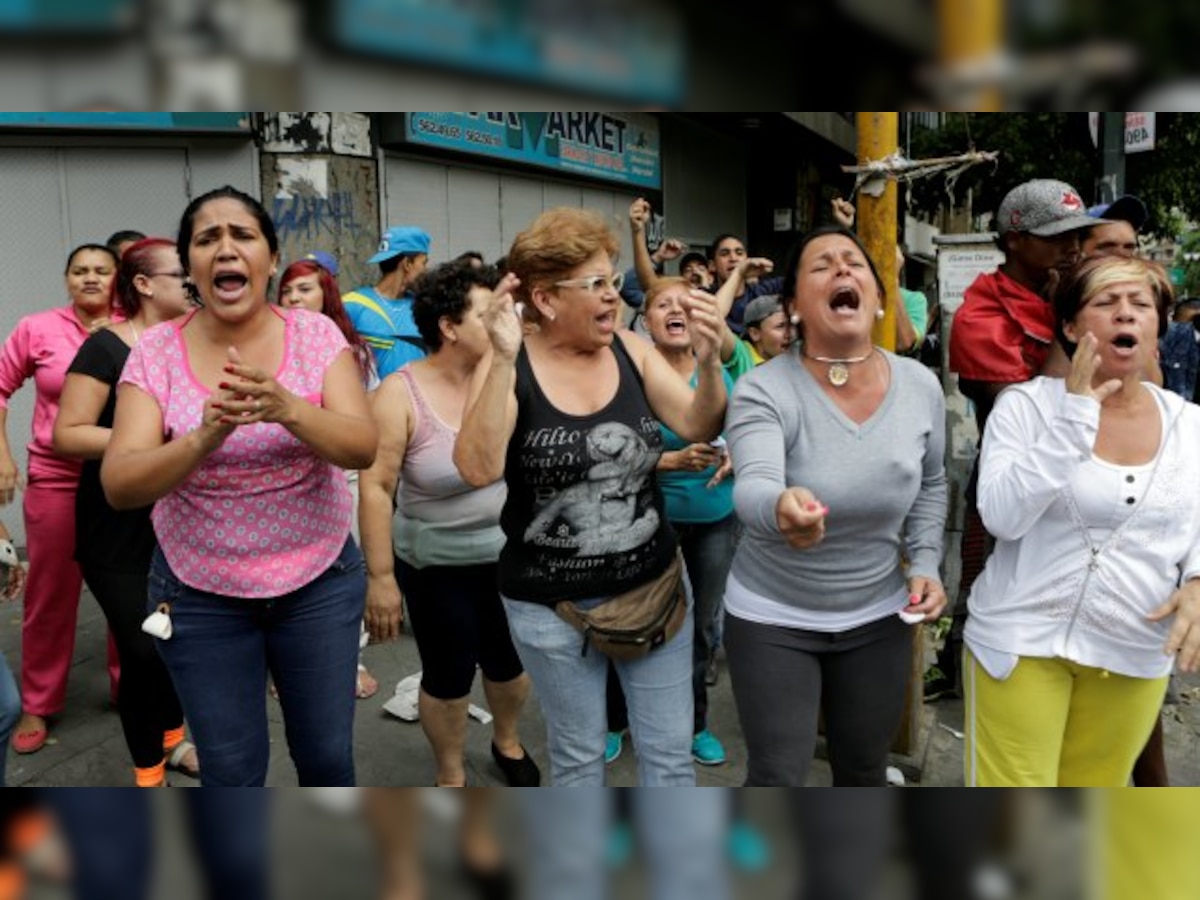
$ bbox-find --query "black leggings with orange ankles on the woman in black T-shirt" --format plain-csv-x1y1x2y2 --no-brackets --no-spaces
82,564,184,769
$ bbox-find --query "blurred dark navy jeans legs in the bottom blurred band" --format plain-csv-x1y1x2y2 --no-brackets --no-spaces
43,787,270,900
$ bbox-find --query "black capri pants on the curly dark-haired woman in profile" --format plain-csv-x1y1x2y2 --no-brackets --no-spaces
396,560,524,700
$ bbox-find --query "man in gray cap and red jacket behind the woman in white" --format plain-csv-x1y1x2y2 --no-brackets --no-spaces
925,179,1097,700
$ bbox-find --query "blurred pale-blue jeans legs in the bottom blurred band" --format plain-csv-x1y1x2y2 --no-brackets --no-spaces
517,787,731,900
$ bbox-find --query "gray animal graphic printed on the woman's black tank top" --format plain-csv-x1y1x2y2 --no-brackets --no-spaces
524,422,659,557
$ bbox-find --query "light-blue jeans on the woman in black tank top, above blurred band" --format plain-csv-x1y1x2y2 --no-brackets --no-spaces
504,588,696,787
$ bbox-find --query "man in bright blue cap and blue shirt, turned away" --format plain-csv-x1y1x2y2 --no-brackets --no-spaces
342,226,430,378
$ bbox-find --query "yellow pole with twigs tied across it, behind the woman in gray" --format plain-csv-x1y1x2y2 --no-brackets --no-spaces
856,113,900,350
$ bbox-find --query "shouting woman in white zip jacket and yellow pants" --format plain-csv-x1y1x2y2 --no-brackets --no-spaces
964,258,1200,787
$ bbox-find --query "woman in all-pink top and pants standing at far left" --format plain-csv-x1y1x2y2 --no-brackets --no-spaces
0,244,116,754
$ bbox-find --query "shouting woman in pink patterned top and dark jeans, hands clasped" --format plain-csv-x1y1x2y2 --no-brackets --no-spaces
101,186,378,786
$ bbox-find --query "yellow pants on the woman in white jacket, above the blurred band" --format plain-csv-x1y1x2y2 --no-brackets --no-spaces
962,650,1168,787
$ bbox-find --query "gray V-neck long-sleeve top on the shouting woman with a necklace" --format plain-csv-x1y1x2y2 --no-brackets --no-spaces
726,350,947,613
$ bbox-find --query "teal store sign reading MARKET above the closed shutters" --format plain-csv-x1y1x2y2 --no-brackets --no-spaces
406,113,662,191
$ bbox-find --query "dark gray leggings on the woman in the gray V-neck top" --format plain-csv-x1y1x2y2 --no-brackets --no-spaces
725,613,913,787
